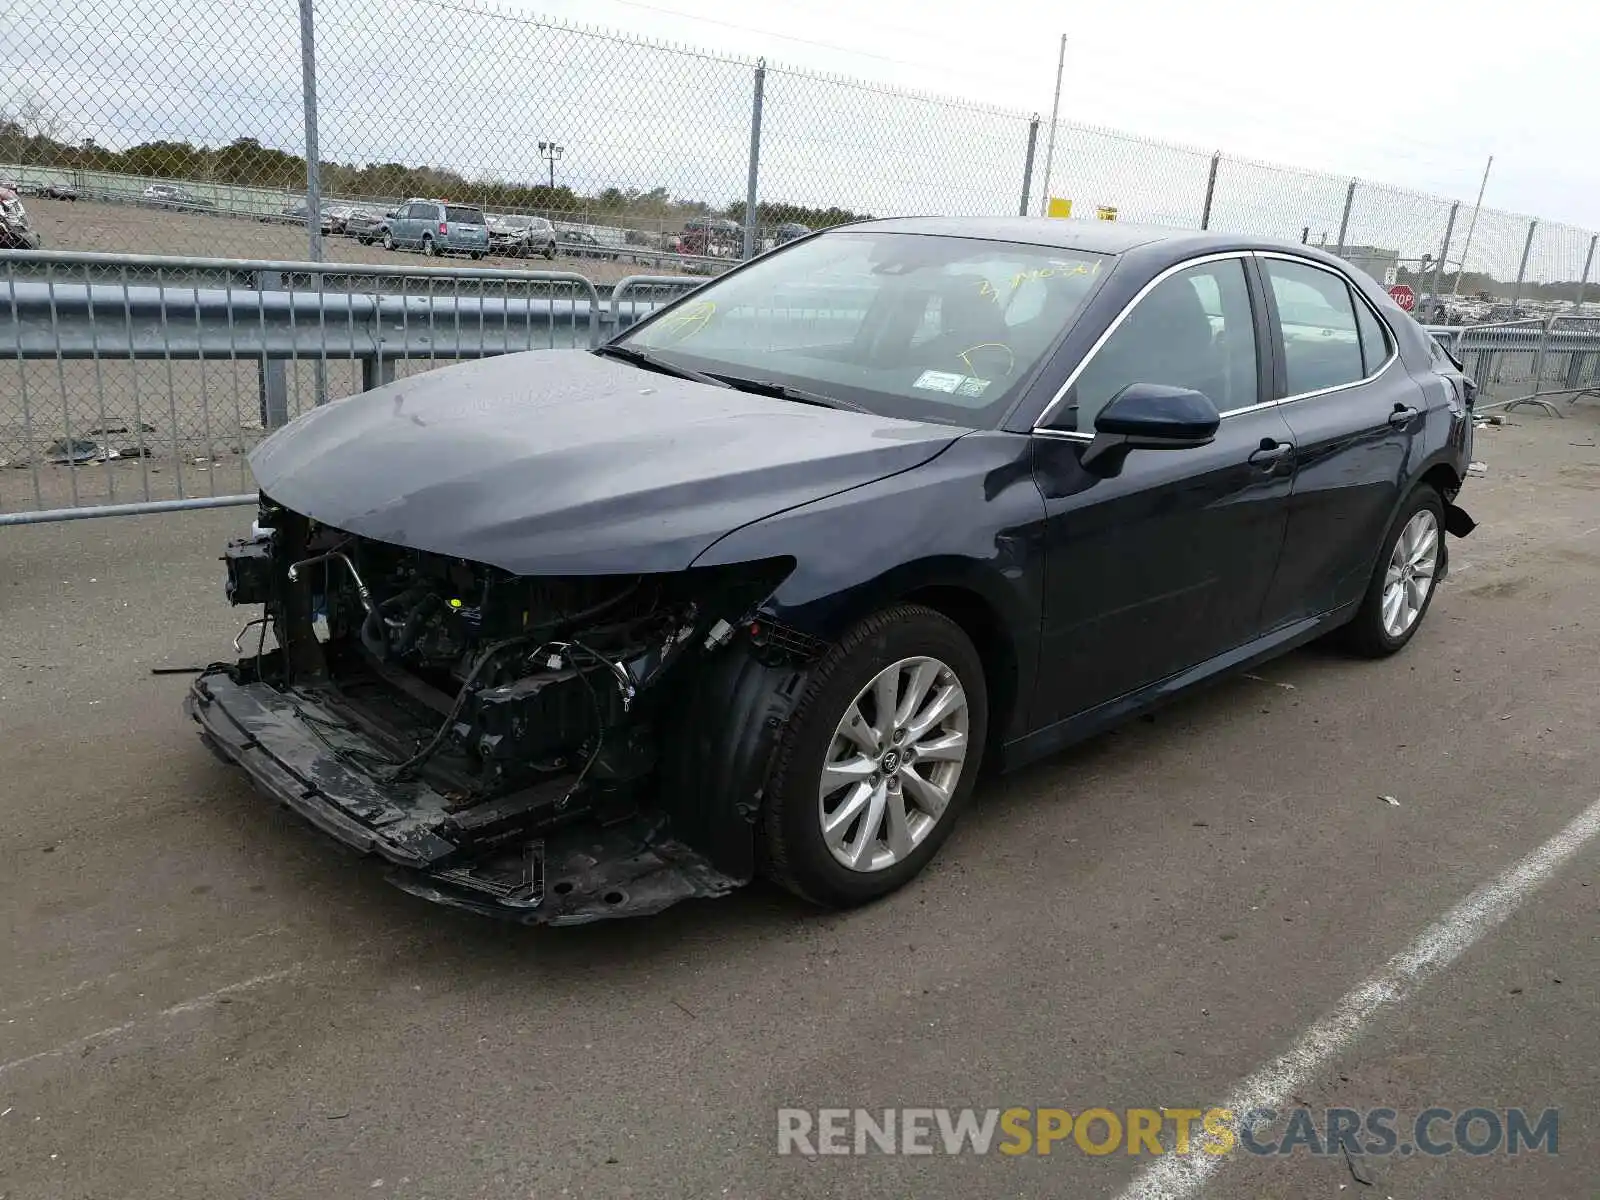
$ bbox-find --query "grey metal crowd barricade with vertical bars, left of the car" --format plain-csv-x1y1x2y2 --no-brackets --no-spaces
0,251,610,525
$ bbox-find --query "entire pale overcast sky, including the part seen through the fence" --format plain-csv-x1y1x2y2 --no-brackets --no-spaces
0,0,1600,280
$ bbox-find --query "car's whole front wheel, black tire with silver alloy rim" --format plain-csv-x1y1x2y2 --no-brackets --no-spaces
763,605,989,907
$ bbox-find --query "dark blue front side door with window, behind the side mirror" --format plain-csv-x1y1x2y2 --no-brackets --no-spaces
1032,254,1294,728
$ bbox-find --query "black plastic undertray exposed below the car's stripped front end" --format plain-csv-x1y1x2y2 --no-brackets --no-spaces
184,672,742,925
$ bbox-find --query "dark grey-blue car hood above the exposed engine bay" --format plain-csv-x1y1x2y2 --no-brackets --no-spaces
250,350,966,574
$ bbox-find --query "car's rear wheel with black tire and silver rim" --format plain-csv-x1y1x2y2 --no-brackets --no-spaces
1341,483,1445,658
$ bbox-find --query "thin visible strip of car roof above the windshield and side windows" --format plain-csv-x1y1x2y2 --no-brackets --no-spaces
842,216,1322,258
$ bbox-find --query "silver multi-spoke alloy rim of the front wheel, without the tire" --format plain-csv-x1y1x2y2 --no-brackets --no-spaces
818,658,968,872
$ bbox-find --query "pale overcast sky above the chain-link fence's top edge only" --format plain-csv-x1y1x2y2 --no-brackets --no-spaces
531,0,1600,227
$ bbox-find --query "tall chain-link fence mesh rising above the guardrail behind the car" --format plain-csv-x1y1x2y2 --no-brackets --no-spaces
9,0,1594,296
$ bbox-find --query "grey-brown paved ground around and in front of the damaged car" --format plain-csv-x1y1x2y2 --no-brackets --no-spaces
9,406,1600,1200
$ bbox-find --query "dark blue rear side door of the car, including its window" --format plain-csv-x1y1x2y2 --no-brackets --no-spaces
1259,253,1427,627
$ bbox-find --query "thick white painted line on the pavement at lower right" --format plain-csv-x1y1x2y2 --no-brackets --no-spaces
1118,800,1600,1200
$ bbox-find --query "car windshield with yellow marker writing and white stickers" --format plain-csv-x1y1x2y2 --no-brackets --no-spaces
618,230,1110,427
